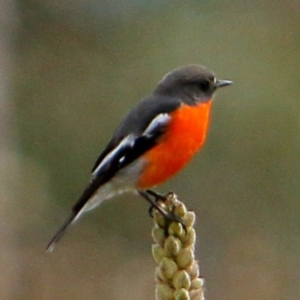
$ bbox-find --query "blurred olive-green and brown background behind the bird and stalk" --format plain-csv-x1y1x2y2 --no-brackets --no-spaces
0,0,300,300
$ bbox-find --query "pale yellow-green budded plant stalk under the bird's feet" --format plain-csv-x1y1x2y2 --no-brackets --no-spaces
152,193,204,300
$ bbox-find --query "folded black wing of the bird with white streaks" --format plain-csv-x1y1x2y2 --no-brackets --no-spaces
85,96,181,204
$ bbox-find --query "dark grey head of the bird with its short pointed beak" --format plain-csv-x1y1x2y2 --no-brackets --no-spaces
154,65,232,103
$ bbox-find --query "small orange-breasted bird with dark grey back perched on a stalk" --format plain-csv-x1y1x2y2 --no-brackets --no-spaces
47,65,232,252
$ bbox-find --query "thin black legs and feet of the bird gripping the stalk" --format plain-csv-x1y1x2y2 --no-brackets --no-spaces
138,190,186,231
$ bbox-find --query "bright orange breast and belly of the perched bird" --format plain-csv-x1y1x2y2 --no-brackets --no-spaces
137,101,211,189
